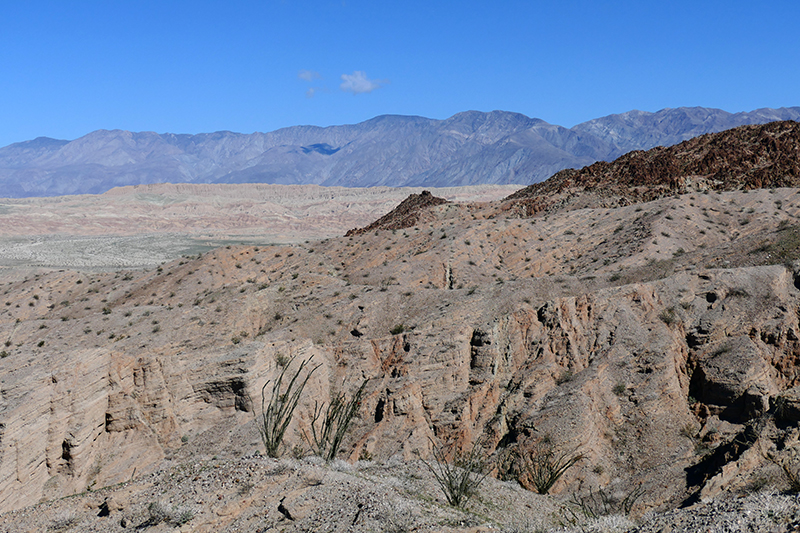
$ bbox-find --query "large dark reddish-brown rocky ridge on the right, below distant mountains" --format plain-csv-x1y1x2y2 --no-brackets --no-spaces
507,121,800,216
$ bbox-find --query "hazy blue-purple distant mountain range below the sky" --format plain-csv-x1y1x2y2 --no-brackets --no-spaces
0,107,800,197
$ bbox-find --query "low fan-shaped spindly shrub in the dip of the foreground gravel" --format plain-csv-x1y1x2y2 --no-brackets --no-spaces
423,441,488,509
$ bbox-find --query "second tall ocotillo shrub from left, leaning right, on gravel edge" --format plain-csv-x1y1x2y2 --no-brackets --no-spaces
304,379,369,461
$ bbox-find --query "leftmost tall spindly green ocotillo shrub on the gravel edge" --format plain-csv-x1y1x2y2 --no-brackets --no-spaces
256,357,319,457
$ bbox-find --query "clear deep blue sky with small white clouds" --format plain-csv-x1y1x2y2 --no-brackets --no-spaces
0,0,800,146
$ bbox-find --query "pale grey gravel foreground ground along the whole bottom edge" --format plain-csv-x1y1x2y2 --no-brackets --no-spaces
0,455,800,533
